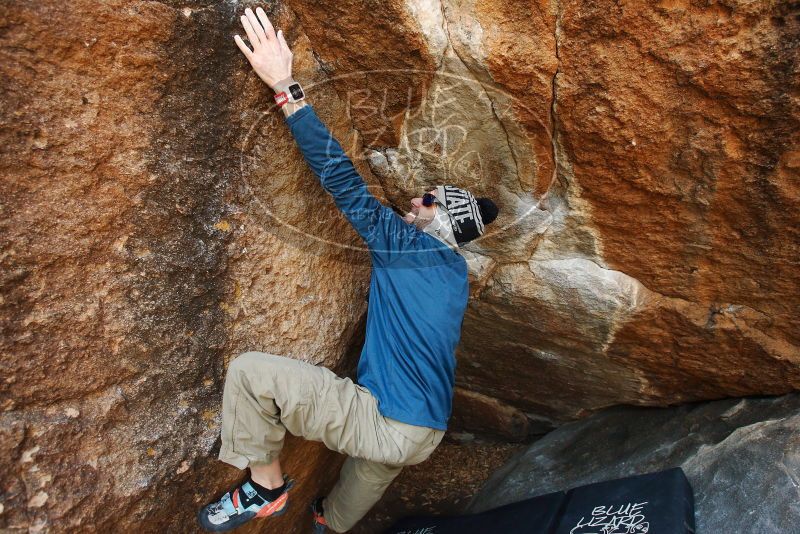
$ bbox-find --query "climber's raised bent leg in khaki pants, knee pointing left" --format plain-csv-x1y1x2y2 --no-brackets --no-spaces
219,352,443,469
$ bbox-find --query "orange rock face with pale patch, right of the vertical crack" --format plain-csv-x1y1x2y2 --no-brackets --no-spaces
454,1,800,428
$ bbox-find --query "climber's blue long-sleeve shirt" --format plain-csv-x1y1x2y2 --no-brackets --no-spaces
286,105,469,430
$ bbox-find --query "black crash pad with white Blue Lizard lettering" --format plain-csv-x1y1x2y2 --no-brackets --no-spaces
385,467,694,534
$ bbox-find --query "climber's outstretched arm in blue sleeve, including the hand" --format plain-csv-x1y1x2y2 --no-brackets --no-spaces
234,4,415,263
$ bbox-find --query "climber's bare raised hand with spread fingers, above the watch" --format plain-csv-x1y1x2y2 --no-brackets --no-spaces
233,7,292,88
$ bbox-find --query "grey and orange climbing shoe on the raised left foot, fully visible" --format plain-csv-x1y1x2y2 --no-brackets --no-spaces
197,475,294,532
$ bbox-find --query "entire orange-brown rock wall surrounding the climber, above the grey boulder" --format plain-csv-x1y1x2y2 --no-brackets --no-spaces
0,0,800,532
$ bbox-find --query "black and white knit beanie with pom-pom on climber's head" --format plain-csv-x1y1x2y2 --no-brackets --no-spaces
436,185,500,246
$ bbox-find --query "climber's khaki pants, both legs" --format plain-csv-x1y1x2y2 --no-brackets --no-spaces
219,352,445,532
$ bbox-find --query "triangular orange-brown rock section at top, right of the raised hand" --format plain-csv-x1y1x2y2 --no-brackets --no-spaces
286,0,436,146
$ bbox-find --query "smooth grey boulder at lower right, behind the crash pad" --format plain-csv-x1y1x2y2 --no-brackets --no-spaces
467,394,800,534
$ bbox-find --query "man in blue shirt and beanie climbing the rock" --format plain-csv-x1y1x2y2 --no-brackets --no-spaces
198,7,498,533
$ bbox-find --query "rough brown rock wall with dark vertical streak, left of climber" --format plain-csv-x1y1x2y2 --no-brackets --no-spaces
0,2,369,532
